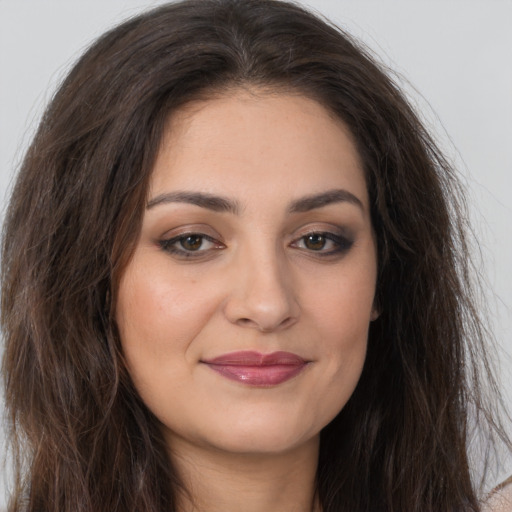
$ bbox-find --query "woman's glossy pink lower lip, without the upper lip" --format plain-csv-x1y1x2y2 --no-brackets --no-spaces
207,363,306,387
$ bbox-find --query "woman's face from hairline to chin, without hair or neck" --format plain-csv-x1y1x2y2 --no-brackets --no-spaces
116,91,377,453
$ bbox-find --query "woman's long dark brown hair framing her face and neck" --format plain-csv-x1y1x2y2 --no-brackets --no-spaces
2,0,510,512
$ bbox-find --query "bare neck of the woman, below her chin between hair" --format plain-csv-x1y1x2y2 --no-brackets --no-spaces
171,438,320,512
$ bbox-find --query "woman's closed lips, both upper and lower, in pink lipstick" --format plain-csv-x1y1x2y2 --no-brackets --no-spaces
203,351,308,387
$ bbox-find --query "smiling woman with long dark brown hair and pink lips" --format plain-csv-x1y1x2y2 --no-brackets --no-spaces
2,0,506,512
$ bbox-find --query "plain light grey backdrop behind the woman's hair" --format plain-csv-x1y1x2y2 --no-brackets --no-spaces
0,0,512,509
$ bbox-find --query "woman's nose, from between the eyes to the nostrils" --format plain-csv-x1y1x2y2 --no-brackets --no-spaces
224,244,300,332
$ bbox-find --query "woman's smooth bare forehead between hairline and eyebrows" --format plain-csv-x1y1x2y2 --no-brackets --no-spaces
150,90,368,208
